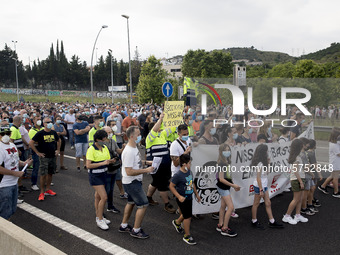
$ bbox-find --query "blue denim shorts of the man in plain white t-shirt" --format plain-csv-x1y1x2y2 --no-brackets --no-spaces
123,180,149,208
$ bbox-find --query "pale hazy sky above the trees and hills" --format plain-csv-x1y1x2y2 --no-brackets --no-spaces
0,0,340,65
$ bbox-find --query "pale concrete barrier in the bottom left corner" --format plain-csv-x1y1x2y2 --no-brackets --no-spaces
0,217,65,255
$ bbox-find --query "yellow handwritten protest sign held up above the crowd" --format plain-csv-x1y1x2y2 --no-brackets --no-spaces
163,101,184,128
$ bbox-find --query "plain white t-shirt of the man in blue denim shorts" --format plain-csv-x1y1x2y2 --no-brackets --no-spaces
122,145,143,184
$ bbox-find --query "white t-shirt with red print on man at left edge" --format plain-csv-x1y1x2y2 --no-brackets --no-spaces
0,142,19,188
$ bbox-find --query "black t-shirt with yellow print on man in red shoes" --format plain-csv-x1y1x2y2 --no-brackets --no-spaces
32,130,59,158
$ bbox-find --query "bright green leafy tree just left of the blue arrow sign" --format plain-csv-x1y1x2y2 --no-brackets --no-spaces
137,56,168,103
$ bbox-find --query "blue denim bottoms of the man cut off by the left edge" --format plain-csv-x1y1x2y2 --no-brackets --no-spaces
0,184,18,220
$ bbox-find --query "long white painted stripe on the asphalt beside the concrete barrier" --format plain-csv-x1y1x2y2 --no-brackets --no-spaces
18,203,135,255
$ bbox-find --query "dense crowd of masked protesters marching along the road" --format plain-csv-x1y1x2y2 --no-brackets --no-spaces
0,100,340,245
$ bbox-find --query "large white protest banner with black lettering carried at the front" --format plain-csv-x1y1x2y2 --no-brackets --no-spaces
191,122,314,214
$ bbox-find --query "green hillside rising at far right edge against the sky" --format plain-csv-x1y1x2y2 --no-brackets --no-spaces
301,43,340,63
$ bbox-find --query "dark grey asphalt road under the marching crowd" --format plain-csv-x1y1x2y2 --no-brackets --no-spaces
12,142,340,255
